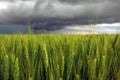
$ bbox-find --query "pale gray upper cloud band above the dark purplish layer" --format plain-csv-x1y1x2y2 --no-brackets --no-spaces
0,0,120,18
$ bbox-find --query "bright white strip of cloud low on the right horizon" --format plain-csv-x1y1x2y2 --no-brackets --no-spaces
57,23,120,34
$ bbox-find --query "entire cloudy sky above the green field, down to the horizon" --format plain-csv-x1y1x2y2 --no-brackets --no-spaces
0,0,120,32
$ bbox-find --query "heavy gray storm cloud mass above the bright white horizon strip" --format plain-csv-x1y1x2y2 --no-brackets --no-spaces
0,0,120,30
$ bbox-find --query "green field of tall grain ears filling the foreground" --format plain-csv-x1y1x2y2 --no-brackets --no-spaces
0,34,120,80
